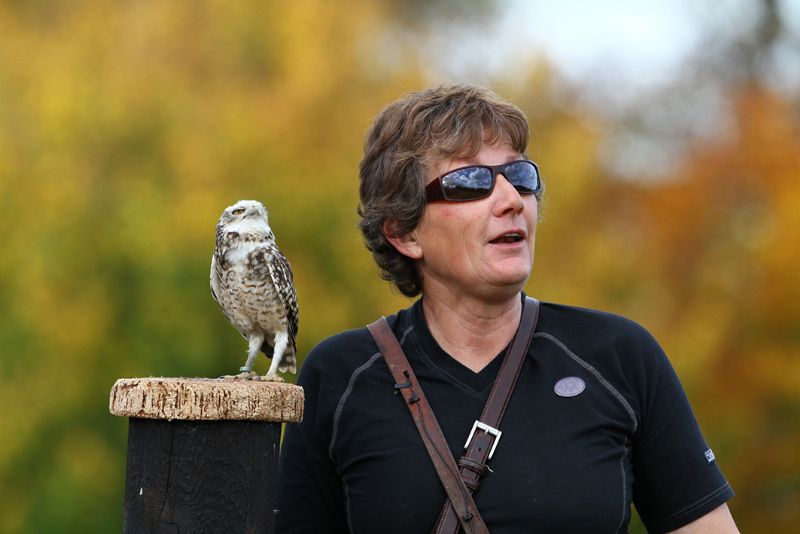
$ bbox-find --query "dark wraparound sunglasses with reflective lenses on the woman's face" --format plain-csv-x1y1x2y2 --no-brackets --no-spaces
425,159,542,202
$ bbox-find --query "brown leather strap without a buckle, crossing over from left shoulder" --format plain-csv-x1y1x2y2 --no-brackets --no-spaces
367,317,489,534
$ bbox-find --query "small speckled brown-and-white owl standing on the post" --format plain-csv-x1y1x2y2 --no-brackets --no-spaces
211,200,298,380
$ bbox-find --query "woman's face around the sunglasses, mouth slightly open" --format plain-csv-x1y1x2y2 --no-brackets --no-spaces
401,143,538,300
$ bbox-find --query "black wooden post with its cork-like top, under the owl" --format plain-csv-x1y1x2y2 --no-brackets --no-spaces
109,378,304,534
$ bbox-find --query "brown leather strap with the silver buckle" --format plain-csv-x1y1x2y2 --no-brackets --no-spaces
435,297,539,534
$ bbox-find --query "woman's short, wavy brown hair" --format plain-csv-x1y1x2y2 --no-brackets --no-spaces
358,85,538,297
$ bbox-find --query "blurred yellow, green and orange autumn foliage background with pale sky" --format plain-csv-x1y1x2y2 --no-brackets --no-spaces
0,0,800,533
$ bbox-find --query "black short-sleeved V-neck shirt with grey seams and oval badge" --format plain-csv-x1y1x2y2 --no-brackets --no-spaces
277,301,733,533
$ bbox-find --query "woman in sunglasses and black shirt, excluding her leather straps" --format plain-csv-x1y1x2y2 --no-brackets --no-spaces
277,85,737,533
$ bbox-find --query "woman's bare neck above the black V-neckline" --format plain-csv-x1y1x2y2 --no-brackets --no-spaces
422,292,522,373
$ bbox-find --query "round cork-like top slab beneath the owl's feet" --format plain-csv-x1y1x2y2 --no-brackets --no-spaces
109,377,304,423
